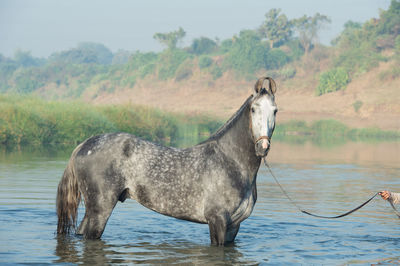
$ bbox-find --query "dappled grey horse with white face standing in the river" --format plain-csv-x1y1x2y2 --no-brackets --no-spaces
57,77,277,245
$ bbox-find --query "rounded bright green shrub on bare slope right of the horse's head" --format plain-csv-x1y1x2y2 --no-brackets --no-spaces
316,67,350,95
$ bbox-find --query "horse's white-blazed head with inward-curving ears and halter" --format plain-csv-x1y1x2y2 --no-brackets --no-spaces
250,77,278,157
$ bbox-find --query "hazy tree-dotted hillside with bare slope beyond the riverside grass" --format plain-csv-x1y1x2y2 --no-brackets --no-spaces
0,0,400,130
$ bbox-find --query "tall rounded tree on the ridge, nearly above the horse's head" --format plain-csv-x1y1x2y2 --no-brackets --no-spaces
258,8,292,49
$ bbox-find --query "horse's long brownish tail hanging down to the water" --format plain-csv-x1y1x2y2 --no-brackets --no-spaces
56,144,82,234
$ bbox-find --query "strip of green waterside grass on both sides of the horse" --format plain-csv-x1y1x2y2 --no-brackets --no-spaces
0,95,400,147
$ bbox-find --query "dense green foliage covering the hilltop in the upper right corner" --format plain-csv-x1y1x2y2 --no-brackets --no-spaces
316,0,400,95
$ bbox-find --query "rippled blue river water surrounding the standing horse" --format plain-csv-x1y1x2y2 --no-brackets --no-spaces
0,143,400,265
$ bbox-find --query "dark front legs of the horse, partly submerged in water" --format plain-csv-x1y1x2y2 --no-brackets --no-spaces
206,210,240,246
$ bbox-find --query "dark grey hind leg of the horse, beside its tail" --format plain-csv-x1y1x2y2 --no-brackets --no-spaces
77,187,118,239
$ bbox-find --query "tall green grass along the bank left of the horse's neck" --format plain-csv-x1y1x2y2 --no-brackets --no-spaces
0,95,221,146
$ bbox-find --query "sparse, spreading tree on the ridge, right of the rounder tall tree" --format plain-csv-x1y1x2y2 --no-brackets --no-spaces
293,13,331,54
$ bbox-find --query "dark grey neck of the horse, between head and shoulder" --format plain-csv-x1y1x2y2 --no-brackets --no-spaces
217,103,261,171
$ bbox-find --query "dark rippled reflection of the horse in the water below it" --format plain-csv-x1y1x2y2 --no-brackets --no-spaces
53,236,256,265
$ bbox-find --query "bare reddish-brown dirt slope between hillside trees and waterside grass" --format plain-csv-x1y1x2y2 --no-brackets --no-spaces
90,60,400,130
